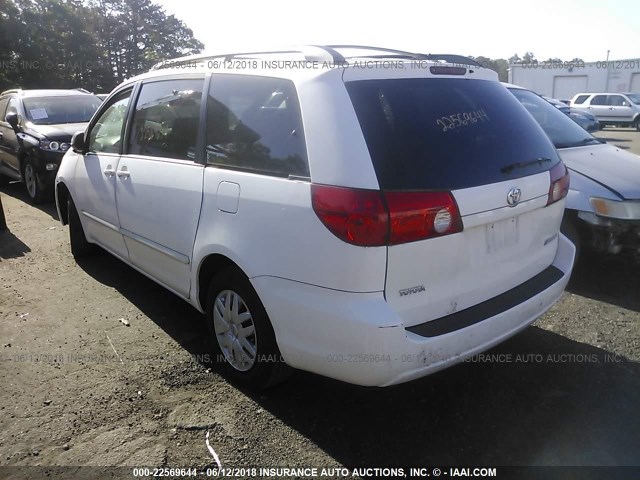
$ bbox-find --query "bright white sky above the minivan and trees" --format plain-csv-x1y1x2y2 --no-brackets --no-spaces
155,0,640,62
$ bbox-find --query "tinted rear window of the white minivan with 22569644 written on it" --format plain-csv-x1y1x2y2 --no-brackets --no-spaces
346,78,559,190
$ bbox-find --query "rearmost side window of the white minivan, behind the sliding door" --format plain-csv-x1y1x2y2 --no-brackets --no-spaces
206,75,309,177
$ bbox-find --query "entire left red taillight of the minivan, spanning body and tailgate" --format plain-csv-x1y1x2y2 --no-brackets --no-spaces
311,184,462,247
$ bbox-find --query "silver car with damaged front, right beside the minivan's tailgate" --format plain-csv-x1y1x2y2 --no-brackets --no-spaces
508,85,640,258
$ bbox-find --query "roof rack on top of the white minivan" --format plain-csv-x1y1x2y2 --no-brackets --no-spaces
151,45,482,70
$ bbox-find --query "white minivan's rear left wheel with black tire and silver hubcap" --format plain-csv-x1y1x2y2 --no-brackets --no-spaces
206,268,290,390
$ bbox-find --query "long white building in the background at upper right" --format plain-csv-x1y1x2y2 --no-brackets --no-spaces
509,58,640,100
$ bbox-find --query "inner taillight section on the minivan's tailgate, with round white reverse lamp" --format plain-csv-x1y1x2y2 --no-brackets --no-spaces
384,192,462,245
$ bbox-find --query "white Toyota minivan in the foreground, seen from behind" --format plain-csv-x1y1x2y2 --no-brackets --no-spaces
56,46,575,388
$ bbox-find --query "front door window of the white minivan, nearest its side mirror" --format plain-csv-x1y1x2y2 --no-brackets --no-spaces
89,90,131,153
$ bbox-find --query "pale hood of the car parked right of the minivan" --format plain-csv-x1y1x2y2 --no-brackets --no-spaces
558,144,640,199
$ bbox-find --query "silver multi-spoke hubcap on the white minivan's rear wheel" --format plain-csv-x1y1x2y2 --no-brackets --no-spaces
213,290,258,372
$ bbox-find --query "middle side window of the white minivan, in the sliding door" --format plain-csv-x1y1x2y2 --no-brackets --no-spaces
128,79,204,160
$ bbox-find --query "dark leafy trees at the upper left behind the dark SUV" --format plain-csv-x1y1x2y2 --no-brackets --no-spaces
0,0,203,92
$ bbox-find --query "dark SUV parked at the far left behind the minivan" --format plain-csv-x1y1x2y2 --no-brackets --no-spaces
0,90,102,203
